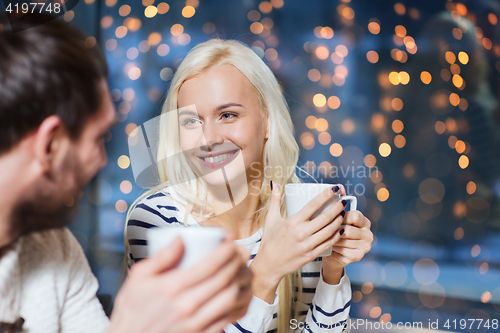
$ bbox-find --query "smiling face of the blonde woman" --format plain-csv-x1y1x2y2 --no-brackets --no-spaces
177,65,267,185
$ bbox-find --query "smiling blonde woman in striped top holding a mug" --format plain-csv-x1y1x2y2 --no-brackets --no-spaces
126,40,373,333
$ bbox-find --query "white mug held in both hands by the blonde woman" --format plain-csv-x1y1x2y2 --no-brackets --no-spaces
285,183,358,257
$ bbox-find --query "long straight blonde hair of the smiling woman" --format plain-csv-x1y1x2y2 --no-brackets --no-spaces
125,39,302,333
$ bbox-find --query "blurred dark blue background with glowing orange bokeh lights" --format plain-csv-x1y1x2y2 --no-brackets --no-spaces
3,0,500,332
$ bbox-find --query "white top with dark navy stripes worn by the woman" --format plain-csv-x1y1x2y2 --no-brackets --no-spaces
127,187,351,333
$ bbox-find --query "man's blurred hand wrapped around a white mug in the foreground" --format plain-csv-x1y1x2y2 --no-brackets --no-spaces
108,238,252,333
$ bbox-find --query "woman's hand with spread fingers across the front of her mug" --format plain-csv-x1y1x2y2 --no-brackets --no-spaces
250,183,344,303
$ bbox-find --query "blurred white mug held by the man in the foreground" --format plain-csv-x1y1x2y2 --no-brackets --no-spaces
146,226,226,268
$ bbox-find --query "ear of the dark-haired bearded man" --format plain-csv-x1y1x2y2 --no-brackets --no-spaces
33,115,64,171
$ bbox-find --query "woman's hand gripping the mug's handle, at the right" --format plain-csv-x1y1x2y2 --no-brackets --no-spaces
323,206,373,284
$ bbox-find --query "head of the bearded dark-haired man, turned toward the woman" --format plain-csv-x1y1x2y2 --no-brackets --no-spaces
0,14,115,247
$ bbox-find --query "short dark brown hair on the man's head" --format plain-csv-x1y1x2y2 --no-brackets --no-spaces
0,13,108,154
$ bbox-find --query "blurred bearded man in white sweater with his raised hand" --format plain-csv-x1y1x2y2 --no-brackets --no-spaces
0,14,252,333
